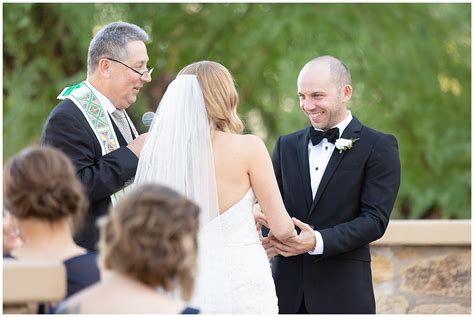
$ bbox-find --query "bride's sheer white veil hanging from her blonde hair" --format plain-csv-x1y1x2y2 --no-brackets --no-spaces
134,75,219,227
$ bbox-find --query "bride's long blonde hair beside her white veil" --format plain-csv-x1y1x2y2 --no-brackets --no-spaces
178,61,244,133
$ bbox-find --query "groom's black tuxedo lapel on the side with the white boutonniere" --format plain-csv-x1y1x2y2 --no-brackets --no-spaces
308,117,362,218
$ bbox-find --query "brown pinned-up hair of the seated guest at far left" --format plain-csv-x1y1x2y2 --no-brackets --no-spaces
3,146,88,229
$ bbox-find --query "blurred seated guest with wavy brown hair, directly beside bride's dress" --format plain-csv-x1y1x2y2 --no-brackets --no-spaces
56,185,199,314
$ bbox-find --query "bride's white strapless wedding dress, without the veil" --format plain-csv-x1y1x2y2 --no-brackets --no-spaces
191,188,278,314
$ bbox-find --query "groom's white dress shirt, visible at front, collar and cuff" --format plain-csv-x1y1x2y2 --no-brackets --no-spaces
308,110,352,255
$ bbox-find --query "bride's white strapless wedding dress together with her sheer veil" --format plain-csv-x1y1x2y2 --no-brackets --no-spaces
133,75,278,314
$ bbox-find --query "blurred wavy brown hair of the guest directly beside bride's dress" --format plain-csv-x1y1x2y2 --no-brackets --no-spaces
100,184,199,300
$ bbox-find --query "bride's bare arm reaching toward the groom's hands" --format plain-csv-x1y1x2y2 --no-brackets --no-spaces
246,135,296,240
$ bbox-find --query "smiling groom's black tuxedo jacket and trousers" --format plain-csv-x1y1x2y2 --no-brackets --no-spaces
272,117,400,314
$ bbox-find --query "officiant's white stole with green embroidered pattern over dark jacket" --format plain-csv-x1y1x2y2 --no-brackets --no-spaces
57,81,124,205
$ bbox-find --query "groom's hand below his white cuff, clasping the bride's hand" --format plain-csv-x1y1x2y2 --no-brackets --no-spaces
271,217,316,257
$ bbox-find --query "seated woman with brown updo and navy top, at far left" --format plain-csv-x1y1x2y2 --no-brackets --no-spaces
3,146,100,297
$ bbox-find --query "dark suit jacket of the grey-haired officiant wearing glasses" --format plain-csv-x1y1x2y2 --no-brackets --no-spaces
41,99,138,251
